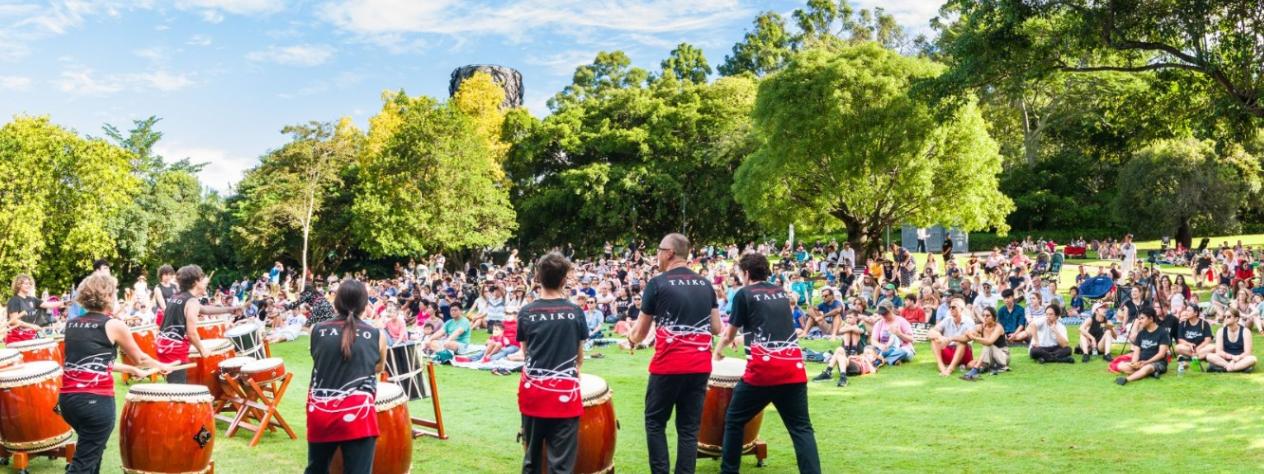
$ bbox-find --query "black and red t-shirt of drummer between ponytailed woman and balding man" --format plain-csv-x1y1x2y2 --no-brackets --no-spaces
517,300,588,418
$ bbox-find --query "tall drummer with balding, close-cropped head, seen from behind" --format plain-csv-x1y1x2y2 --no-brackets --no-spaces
628,234,720,474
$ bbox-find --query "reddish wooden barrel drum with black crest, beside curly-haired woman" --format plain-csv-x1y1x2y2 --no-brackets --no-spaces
119,391,215,473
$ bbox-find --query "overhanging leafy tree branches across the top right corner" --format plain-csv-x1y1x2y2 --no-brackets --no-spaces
940,0,1264,124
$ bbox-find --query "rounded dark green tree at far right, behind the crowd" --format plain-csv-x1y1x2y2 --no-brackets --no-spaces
1115,138,1260,248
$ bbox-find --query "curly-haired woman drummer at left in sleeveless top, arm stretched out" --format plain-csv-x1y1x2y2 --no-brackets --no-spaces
58,274,171,474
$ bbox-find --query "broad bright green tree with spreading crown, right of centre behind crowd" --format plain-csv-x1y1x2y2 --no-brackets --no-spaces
733,43,1014,264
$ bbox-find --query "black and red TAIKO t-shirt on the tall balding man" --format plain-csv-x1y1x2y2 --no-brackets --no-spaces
641,267,718,375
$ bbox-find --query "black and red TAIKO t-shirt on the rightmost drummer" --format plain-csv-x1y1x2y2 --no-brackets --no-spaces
729,282,808,387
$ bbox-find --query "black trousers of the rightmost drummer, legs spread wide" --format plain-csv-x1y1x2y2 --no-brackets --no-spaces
719,382,820,474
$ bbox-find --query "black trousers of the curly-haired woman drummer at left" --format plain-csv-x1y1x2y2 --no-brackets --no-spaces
58,393,115,474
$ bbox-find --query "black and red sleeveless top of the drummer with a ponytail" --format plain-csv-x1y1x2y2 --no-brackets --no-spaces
307,319,382,442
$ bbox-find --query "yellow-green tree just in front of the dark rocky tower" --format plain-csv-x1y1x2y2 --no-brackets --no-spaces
351,90,514,257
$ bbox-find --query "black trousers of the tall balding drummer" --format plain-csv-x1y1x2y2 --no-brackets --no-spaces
645,374,710,474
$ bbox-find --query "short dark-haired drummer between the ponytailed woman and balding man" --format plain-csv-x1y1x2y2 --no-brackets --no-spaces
517,252,588,474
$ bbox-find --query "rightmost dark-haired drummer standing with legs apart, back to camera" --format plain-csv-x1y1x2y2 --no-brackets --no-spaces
715,256,820,473
